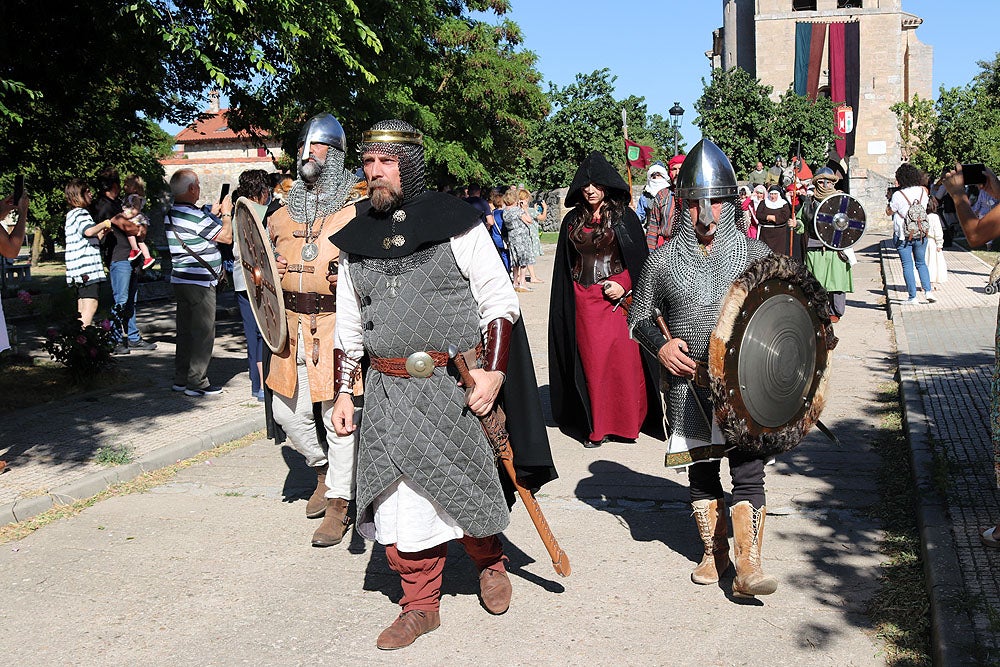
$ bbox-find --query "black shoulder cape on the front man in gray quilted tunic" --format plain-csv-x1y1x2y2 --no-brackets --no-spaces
330,191,480,259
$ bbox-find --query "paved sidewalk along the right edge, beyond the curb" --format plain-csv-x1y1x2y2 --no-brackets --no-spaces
882,234,1000,664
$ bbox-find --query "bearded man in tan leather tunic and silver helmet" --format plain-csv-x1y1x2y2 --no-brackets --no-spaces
267,113,357,547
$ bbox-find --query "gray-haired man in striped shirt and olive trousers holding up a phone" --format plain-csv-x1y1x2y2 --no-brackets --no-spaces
164,169,233,396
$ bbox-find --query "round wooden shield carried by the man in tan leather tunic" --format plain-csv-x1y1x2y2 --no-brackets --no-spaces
233,197,288,353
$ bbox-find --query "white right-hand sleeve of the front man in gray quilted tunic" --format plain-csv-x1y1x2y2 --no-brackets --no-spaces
450,225,521,333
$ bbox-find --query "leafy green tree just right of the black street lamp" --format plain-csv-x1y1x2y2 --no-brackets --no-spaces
695,67,780,177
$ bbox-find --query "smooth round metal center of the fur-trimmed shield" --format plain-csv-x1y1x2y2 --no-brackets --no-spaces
737,294,816,428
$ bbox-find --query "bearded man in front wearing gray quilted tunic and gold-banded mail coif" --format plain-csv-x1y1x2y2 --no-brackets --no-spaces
332,120,555,649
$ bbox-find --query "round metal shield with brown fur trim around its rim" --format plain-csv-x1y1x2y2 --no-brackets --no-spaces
708,255,836,458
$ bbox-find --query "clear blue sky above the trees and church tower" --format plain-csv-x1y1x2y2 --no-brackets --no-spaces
164,0,1000,146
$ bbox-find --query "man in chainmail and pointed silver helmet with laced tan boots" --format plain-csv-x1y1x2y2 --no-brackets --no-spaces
629,139,777,597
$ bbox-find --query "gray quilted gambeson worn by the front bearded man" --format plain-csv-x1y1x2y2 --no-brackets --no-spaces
348,241,510,539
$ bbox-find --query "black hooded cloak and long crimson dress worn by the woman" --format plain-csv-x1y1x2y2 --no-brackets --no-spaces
549,152,662,447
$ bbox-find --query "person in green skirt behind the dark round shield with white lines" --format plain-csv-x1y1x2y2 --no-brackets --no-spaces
798,167,854,322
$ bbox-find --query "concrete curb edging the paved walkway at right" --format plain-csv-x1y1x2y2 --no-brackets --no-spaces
880,241,976,667
